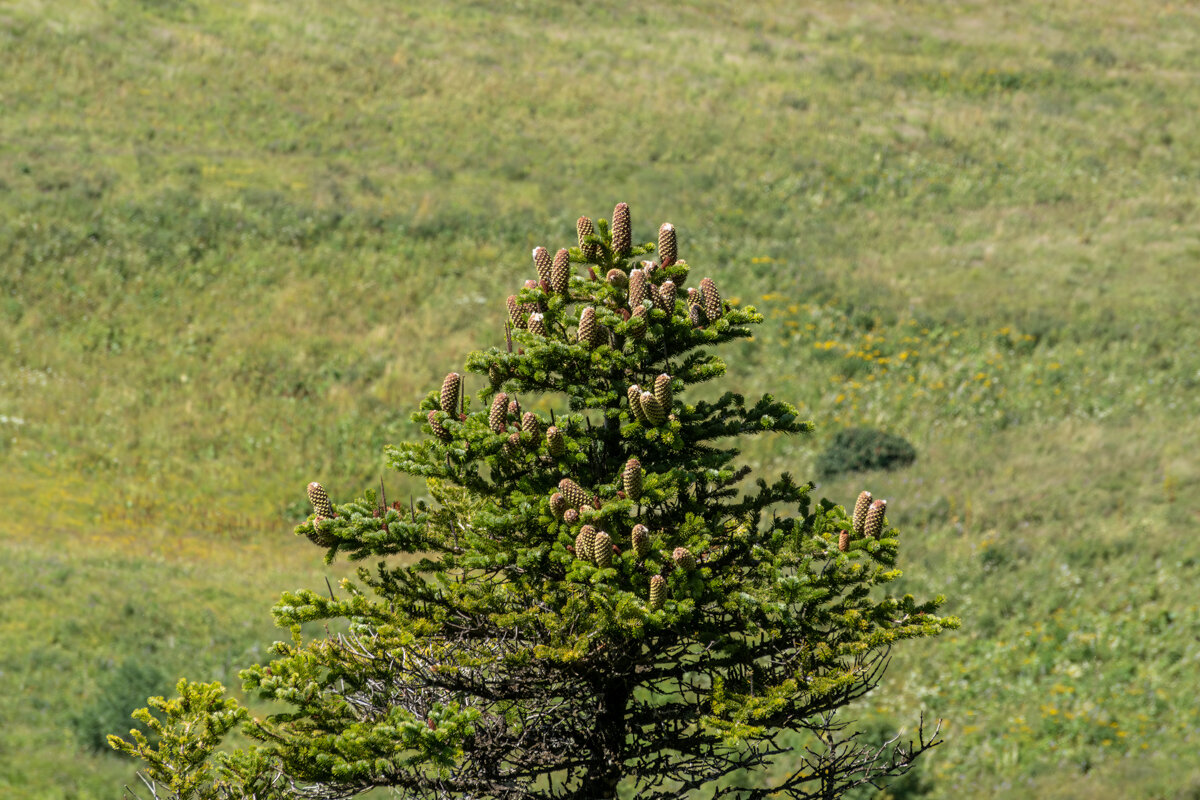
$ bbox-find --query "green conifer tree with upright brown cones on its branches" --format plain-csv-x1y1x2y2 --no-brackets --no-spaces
112,204,958,799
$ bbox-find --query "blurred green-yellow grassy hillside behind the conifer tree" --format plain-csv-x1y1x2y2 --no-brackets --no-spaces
0,0,1200,799
